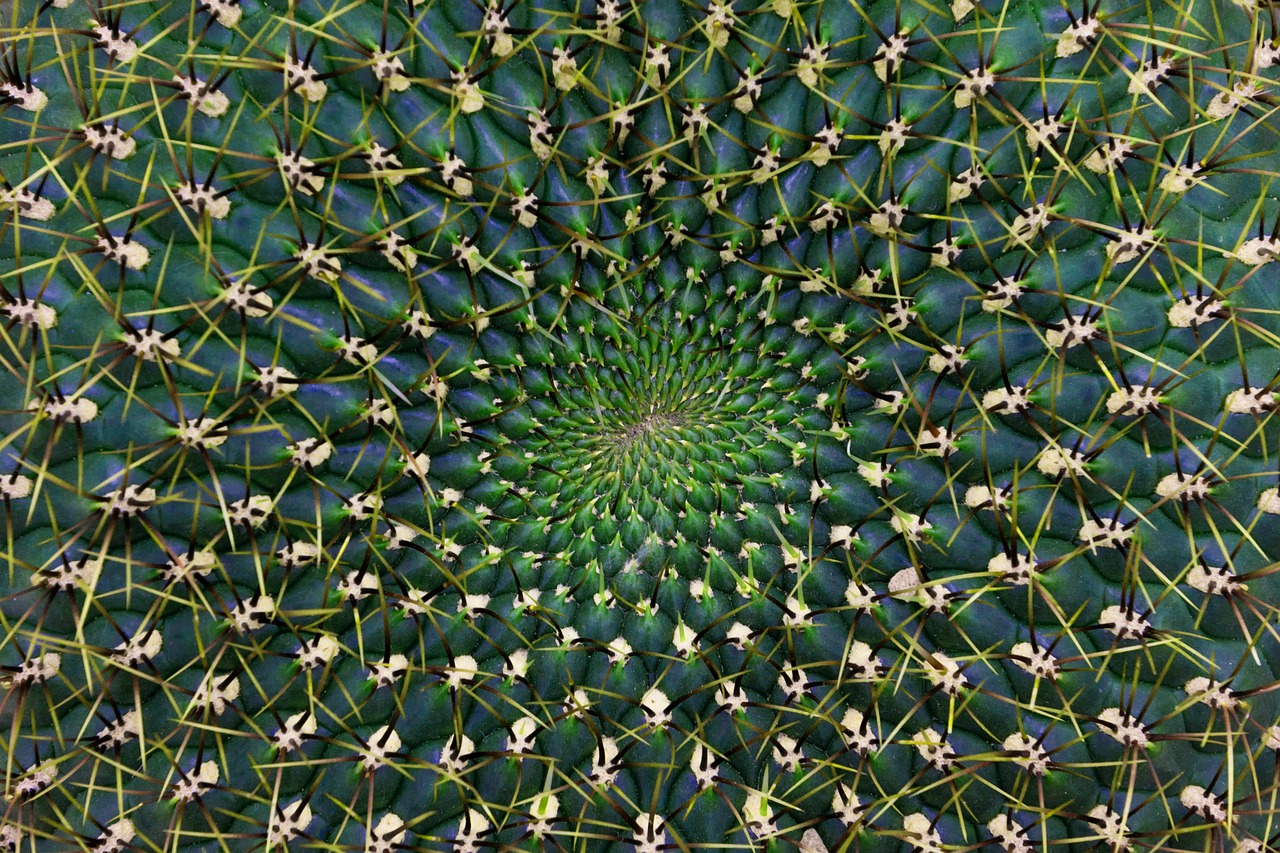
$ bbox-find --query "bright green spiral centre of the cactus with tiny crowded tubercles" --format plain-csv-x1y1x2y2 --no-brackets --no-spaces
507,300,837,551
